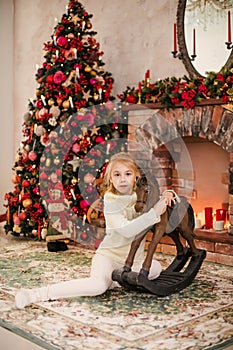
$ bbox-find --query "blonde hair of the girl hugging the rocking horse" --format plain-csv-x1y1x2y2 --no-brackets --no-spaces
104,152,140,193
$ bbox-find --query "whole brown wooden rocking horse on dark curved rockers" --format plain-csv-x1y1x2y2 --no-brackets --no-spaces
112,176,206,297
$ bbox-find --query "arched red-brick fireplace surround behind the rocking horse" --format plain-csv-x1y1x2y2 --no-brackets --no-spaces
123,100,233,265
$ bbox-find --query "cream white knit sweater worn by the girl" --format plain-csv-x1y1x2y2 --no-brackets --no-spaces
97,192,160,265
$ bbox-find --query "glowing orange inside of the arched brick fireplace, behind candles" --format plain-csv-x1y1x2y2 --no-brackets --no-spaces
183,136,229,228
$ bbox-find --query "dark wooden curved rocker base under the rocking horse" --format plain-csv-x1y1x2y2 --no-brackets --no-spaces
112,248,206,297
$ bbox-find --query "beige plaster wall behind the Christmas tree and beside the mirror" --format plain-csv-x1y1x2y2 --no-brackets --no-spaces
0,0,186,213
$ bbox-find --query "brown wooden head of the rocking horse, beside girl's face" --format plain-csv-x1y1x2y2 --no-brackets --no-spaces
135,175,159,213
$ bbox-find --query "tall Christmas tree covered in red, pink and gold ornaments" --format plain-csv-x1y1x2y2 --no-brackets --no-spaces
5,0,126,247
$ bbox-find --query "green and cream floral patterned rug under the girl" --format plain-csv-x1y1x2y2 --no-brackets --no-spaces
0,231,233,350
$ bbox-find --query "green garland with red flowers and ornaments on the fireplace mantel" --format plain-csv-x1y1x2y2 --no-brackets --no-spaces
118,63,233,110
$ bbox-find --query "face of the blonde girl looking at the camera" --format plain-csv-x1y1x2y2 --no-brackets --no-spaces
110,162,136,195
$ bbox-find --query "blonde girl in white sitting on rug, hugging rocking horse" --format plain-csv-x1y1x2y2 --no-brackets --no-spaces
15,152,174,308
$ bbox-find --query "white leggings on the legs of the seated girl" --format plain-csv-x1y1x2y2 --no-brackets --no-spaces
43,253,161,300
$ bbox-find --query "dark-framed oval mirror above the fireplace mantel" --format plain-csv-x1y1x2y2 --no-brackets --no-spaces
177,0,233,76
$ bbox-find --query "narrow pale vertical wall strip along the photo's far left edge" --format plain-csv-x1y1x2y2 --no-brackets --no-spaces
0,0,14,214
